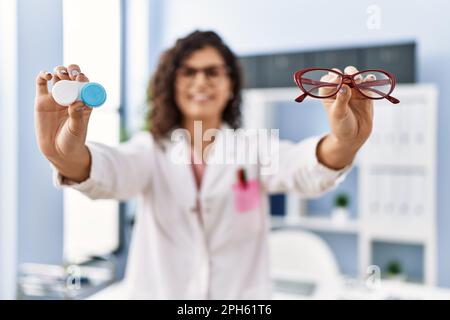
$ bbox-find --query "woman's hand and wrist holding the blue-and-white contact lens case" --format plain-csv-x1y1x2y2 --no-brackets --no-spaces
35,64,92,182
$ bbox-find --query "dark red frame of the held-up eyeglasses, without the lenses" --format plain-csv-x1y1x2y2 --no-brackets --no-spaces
294,68,400,104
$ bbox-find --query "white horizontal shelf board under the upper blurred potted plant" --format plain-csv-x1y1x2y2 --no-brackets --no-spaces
271,217,359,234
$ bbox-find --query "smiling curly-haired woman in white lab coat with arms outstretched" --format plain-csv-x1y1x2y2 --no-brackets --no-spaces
35,31,372,299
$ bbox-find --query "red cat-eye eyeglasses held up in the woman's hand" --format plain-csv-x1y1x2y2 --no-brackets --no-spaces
294,68,400,104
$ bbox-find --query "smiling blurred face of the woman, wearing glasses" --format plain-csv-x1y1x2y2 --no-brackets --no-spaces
175,47,232,121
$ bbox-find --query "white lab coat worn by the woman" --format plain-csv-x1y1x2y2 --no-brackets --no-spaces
55,125,350,299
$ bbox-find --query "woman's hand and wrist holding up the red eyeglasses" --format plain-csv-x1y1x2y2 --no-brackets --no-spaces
317,66,373,169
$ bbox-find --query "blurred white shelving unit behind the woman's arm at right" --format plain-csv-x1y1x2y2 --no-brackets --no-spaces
248,84,438,285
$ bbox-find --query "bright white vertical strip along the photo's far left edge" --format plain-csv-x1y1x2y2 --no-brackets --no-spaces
0,0,18,299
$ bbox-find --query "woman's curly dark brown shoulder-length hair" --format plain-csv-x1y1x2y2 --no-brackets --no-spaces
147,30,242,140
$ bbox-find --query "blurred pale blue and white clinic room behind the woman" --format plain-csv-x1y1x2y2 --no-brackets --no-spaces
0,0,450,299
